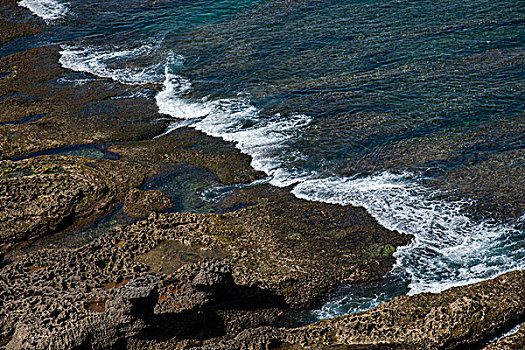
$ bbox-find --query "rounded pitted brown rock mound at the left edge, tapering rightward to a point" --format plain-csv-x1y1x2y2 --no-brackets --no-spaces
0,156,147,249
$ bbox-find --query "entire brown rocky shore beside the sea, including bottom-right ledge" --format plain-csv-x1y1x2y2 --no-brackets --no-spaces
0,0,525,350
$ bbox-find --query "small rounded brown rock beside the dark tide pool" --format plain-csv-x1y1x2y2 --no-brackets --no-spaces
124,189,173,217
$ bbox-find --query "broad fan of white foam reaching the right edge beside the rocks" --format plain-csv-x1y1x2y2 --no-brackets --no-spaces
293,173,525,294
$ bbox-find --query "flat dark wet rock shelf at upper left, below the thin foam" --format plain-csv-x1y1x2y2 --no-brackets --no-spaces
0,47,166,159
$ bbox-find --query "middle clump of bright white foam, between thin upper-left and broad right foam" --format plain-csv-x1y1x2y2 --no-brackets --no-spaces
156,72,311,186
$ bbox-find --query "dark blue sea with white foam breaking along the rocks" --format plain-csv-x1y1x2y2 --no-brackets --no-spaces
8,0,525,318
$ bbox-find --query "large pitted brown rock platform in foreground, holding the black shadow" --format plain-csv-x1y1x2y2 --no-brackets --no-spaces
0,189,409,349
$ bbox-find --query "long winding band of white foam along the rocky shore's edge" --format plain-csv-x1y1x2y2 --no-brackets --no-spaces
60,45,525,317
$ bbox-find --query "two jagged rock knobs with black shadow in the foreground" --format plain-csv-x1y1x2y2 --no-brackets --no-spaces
117,260,288,341
